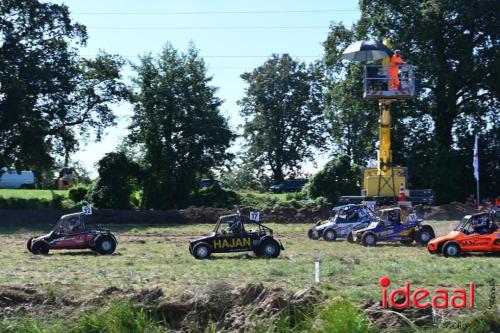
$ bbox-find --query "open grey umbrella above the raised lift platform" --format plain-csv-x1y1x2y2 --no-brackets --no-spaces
340,40,394,62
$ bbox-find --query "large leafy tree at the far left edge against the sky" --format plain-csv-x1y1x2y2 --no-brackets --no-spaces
0,0,127,179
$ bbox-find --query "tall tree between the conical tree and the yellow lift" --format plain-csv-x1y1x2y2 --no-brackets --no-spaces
239,54,325,183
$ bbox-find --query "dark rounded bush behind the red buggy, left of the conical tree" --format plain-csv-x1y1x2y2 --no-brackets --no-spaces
91,152,142,209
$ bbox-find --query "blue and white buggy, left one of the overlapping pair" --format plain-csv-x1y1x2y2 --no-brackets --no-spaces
307,204,377,242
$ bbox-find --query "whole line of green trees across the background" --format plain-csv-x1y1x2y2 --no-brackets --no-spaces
0,0,500,209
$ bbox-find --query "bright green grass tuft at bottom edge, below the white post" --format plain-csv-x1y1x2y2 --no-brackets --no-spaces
310,299,369,333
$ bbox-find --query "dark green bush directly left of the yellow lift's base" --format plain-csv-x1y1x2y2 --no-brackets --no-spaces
304,155,360,203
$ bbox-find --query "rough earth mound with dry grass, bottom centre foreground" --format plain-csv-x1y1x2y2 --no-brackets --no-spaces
157,283,325,332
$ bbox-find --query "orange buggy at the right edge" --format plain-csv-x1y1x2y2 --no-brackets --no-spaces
427,212,500,257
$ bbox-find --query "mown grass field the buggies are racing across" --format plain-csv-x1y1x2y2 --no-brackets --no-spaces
0,222,500,332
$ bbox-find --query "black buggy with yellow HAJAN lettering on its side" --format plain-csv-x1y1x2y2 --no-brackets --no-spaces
189,213,284,259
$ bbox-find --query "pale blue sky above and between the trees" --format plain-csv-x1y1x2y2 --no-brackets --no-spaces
45,0,360,176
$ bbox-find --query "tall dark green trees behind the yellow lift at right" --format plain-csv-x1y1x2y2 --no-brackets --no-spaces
324,0,500,203
